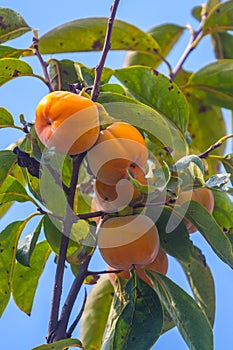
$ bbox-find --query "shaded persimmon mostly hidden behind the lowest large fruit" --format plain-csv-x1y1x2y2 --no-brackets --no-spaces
108,249,168,287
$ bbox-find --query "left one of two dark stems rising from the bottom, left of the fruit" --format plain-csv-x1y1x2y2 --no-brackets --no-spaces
47,153,85,343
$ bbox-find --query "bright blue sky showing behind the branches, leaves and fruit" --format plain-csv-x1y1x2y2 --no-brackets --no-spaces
0,0,233,350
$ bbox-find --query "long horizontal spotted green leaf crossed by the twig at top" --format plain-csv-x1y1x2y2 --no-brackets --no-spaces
39,18,159,54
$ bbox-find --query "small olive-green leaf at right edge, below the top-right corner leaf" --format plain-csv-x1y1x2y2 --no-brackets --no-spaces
211,32,233,59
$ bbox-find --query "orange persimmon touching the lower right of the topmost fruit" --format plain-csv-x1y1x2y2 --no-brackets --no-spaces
87,122,148,185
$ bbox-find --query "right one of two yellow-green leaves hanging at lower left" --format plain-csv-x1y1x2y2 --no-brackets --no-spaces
12,241,51,315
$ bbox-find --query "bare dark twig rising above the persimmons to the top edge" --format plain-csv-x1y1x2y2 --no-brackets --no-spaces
91,0,120,101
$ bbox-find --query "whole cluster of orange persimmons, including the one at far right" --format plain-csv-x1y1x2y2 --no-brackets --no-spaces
35,91,214,285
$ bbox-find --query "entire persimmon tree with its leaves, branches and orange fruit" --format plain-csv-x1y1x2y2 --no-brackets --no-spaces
0,0,233,350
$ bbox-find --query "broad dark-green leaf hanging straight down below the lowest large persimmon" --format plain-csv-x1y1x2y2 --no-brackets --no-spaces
113,275,163,350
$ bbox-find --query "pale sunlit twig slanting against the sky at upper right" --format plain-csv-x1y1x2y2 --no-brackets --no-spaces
170,11,208,80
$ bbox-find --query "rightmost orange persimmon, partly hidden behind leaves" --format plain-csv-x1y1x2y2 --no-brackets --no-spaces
176,187,214,233
